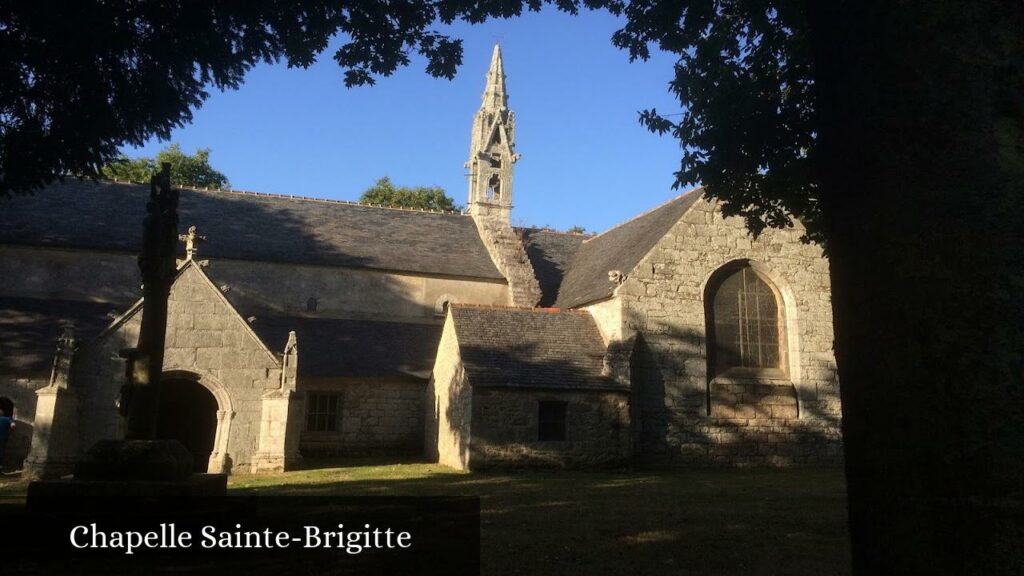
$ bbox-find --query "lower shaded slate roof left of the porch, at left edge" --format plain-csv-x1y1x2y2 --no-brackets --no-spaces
0,297,123,378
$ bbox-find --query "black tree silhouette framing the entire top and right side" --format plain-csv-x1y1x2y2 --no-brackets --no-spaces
0,0,1024,574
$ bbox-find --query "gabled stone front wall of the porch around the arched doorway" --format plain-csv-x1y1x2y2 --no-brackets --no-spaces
73,268,281,471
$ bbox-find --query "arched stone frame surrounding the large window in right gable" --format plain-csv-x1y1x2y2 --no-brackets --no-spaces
705,259,792,383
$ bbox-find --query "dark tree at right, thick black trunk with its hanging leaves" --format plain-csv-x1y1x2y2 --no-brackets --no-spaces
598,0,1024,574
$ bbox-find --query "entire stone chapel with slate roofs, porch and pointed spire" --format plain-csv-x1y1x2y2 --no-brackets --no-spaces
0,46,842,478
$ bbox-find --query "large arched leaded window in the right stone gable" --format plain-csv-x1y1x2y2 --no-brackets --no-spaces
708,264,786,376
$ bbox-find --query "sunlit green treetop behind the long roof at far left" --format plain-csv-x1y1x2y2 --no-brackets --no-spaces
102,143,230,189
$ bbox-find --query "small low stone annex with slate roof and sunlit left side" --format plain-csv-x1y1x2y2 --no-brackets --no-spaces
427,305,633,470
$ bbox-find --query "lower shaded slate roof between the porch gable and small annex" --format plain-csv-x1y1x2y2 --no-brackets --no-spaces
252,317,442,380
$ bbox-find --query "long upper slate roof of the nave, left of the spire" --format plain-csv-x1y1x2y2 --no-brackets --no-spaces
0,178,503,280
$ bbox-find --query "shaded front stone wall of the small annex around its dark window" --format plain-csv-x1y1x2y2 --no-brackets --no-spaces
469,386,632,470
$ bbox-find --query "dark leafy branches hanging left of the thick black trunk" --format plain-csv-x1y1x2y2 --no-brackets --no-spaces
612,0,824,241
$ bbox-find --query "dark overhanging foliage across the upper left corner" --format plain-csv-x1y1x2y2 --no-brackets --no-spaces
0,0,522,196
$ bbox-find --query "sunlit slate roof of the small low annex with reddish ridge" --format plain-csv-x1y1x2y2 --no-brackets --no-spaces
450,304,627,389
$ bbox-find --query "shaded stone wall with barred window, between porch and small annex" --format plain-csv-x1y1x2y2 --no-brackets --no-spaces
300,379,425,458
